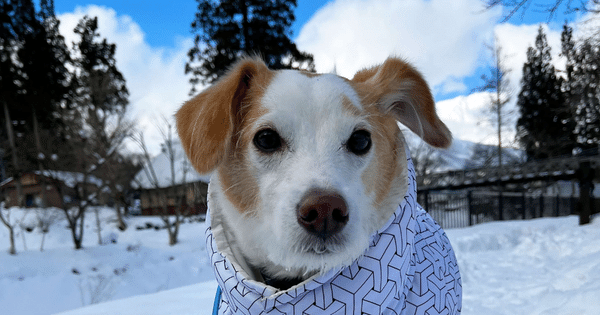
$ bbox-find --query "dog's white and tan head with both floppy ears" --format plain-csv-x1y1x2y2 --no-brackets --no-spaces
176,58,451,277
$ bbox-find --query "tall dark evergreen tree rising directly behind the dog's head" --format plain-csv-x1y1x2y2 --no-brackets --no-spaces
185,0,314,94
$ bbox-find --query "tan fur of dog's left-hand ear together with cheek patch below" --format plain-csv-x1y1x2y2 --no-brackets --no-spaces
176,59,274,212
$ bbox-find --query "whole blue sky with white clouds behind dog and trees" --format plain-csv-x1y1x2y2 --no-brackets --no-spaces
50,0,578,150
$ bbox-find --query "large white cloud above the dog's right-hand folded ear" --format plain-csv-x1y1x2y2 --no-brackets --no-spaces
296,0,501,89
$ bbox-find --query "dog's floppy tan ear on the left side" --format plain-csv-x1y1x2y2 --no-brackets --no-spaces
175,58,270,174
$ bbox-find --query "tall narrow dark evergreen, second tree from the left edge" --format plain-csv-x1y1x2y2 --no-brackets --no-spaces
18,0,71,185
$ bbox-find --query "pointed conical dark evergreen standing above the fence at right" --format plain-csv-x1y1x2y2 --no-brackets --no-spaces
517,26,575,159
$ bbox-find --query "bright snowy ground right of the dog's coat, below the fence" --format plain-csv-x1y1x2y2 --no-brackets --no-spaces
447,216,600,315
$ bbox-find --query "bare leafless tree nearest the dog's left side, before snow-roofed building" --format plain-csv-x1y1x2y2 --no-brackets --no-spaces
133,117,191,246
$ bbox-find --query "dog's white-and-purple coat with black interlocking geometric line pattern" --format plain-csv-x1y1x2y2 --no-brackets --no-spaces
206,154,462,315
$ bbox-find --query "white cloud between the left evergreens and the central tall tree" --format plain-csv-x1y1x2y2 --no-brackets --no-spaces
58,5,192,154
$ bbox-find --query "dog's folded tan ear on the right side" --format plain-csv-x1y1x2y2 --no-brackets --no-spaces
352,58,452,148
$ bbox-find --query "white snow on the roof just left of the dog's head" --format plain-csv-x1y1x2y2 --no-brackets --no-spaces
131,141,210,189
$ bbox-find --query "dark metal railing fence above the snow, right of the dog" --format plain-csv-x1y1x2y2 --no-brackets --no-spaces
418,191,578,228
